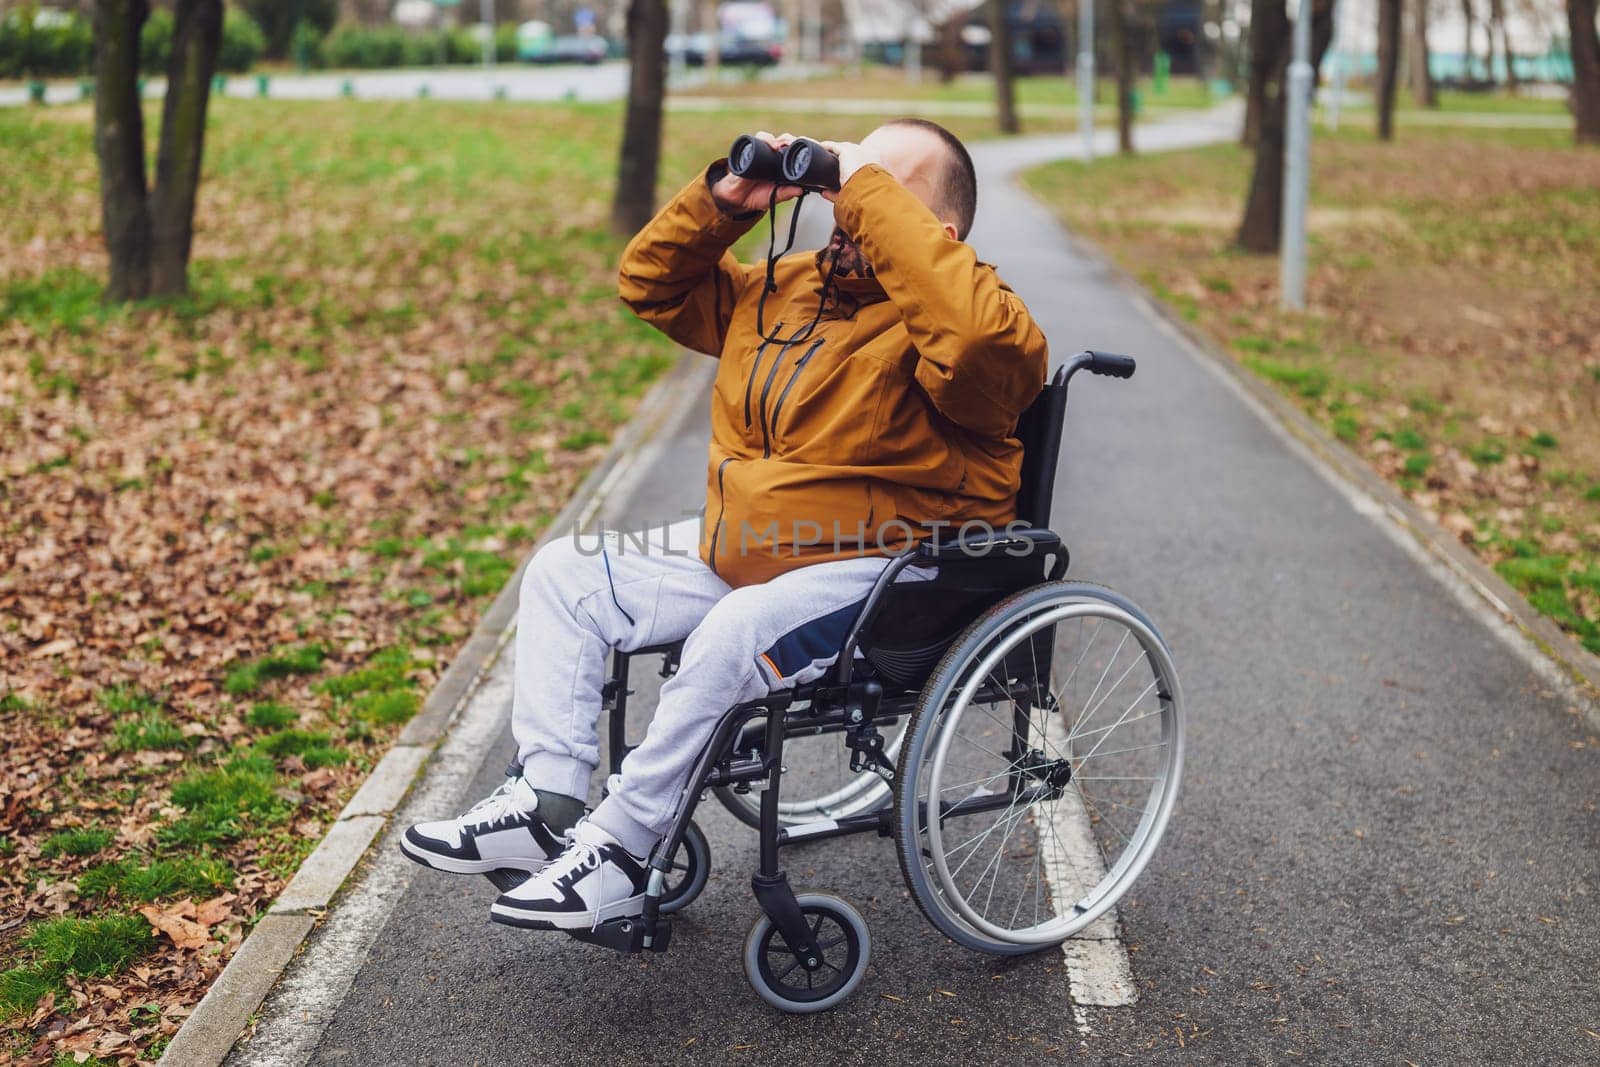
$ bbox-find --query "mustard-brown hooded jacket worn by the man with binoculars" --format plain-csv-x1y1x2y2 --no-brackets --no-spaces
621,163,1048,587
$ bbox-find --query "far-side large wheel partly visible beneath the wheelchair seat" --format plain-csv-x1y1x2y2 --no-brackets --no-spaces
715,726,906,829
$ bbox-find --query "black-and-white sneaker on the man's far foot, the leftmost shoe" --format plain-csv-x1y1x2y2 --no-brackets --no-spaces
400,774,563,875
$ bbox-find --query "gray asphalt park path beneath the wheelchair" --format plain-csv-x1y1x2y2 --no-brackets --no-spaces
235,112,1600,1064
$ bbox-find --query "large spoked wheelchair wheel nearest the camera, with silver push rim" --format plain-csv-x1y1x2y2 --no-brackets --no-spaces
894,582,1184,955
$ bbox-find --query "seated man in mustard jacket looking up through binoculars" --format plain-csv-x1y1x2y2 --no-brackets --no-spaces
402,118,1046,929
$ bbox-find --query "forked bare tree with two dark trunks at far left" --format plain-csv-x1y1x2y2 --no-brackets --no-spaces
94,0,222,302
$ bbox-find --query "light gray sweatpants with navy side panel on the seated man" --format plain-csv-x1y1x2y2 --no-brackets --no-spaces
512,518,886,856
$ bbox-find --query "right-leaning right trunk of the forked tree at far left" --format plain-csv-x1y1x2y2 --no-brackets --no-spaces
150,0,222,296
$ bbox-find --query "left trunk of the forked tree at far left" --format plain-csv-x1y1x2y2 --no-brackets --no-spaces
94,0,150,302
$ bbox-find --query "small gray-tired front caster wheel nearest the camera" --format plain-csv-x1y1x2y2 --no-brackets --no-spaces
744,893,872,1013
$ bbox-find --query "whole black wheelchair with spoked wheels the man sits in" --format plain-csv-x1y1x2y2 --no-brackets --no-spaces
505,352,1184,1013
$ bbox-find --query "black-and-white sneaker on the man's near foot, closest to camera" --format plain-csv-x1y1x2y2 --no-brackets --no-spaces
490,819,650,929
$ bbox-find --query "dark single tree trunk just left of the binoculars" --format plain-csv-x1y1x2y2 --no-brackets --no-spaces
611,0,667,235
